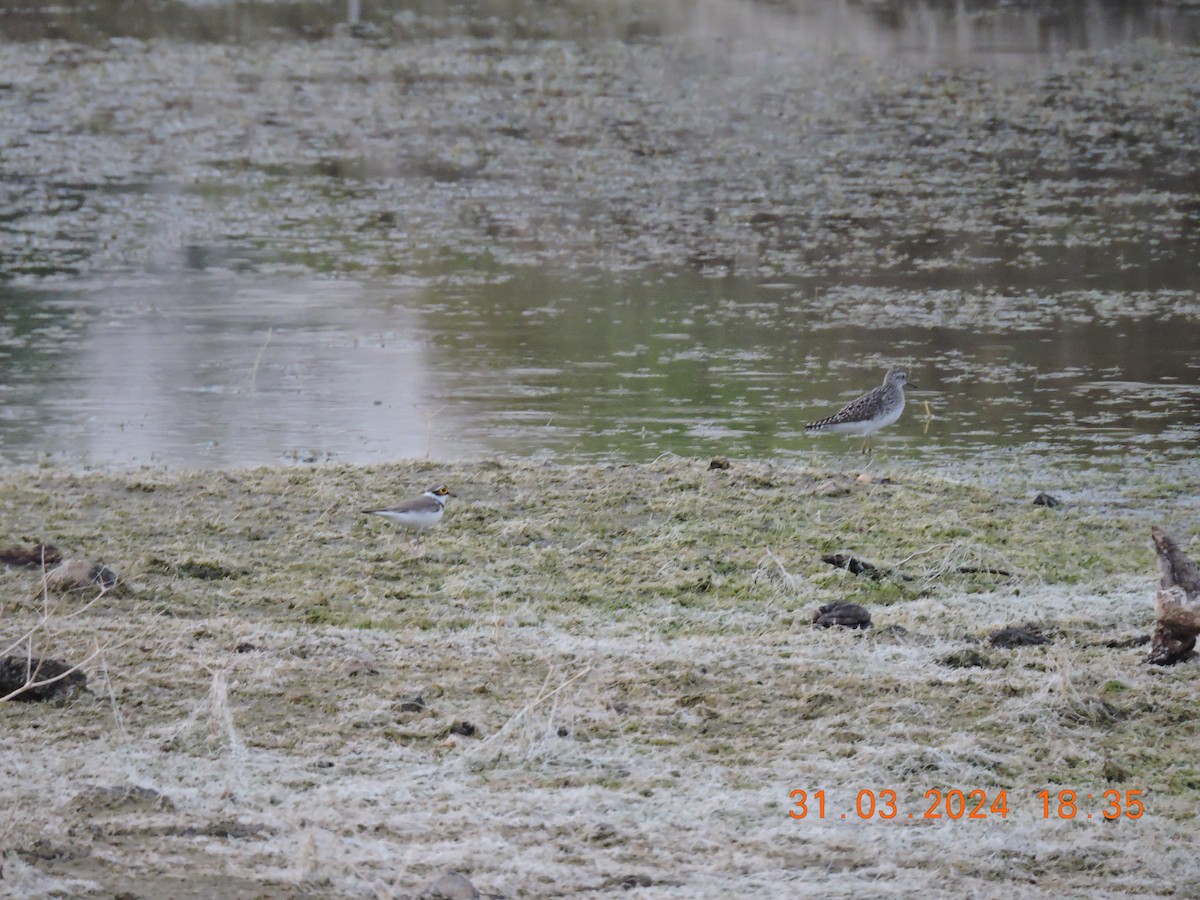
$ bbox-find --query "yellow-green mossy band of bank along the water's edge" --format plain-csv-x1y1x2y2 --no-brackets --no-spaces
0,458,1165,630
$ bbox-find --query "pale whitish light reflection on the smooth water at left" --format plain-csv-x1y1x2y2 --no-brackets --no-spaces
0,278,438,466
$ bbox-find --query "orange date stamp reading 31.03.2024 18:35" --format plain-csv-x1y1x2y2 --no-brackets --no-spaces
787,787,1146,822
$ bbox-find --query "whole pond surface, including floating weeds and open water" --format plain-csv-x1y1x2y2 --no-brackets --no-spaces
0,1,1200,482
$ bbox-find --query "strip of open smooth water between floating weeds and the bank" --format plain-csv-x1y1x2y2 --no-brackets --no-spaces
0,274,1200,480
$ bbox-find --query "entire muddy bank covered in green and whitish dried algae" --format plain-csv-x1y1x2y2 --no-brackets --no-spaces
0,458,1200,898
